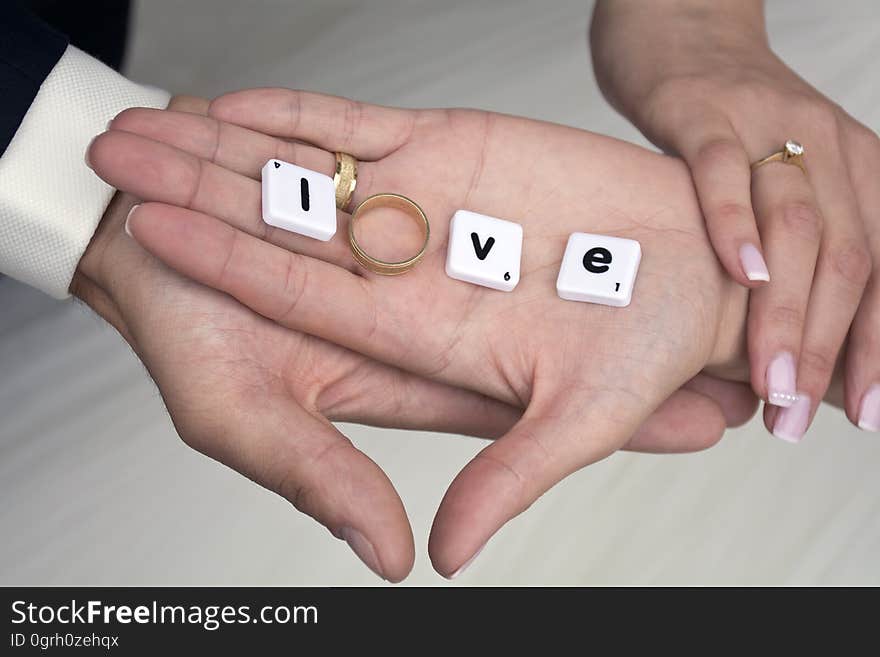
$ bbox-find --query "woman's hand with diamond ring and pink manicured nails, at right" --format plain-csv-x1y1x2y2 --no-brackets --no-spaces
591,0,880,440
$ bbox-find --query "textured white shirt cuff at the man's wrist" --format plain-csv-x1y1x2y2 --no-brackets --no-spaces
0,46,169,299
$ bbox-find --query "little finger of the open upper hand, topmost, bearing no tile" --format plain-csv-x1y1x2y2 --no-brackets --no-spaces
208,88,417,161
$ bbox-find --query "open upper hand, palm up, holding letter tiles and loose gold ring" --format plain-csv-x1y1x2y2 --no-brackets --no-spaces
90,89,760,575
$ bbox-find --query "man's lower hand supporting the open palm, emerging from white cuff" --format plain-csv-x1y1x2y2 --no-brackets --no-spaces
72,98,754,581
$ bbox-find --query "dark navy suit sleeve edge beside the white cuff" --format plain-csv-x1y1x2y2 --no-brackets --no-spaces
0,0,68,155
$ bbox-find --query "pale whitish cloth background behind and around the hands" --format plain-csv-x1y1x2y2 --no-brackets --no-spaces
0,0,880,585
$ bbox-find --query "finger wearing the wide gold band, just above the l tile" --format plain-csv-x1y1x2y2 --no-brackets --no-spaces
108,107,336,180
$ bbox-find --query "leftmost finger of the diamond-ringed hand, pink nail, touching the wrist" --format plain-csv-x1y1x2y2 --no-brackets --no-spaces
678,119,770,287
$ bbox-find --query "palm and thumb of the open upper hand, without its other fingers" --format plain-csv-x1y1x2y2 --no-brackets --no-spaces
320,107,744,572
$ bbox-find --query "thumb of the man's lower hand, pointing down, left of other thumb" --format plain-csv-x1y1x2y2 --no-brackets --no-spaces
180,390,415,582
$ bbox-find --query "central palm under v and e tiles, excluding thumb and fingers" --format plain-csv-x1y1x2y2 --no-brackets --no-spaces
368,111,727,408
